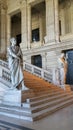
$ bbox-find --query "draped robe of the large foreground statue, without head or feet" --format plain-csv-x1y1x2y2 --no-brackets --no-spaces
8,46,24,88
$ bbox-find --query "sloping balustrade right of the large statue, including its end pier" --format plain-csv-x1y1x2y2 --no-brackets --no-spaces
24,62,65,89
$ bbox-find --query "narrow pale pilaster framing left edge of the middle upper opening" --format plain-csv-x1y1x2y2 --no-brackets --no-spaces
27,4,32,49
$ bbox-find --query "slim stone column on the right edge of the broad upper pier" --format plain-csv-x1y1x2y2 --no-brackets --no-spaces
54,0,59,42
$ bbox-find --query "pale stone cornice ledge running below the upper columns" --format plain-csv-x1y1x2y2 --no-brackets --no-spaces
22,39,73,56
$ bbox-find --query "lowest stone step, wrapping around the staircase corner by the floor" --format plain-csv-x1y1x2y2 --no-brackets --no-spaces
0,95,73,121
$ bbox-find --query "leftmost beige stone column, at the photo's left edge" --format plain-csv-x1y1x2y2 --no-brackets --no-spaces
0,5,6,53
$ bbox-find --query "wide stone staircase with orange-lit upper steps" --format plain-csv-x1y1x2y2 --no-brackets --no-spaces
0,71,73,121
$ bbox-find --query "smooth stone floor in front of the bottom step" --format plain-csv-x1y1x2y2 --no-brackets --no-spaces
0,105,73,130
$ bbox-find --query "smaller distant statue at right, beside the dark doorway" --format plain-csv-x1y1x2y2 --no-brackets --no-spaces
58,53,67,85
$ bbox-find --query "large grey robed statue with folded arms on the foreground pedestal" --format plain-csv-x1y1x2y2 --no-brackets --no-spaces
7,37,28,90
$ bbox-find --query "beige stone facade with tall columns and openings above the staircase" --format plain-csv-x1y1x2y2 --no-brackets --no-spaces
0,0,73,70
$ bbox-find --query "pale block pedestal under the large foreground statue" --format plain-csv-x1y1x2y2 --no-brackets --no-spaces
2,90,22,106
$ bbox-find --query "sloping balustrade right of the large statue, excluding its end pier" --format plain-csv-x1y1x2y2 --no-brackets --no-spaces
24,62,53,83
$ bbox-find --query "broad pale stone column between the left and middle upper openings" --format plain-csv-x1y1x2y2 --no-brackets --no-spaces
21,1,27,50
